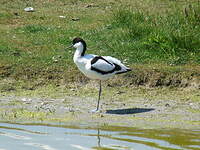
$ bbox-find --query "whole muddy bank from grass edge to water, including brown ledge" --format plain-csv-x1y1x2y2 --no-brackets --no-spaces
0,65,200,129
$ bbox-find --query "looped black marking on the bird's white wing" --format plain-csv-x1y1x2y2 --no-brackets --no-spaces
91,56,121,75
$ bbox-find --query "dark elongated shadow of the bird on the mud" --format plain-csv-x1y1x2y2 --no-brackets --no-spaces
106,108,155,115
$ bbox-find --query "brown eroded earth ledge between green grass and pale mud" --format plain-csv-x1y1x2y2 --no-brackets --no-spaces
0,64,200,92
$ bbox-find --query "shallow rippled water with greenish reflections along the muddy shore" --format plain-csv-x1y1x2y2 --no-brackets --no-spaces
0,123,200,150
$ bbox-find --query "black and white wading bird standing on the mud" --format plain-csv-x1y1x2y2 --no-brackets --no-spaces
70,37,131,112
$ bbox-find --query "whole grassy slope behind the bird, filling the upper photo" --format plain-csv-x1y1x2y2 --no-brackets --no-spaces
0,0,200,88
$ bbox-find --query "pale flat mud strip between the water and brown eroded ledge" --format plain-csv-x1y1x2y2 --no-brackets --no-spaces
0,85,200,129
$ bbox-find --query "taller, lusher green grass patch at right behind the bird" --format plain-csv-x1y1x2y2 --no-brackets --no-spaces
86,6,200,65
